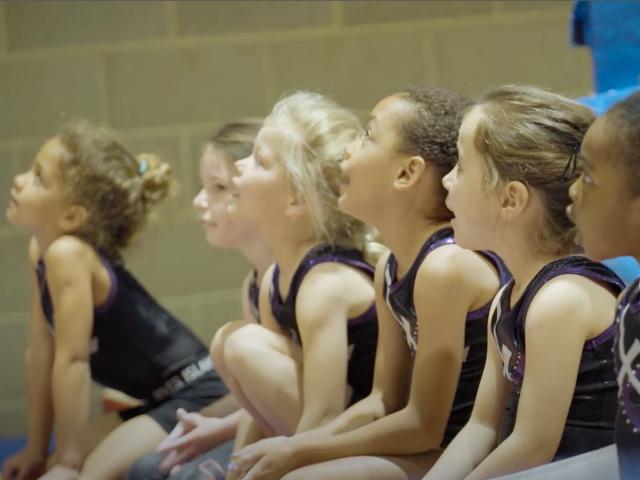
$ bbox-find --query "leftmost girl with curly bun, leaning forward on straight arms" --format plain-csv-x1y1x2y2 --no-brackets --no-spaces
3,123,227,479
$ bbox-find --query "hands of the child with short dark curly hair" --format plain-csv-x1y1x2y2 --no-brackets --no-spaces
227,436,292,480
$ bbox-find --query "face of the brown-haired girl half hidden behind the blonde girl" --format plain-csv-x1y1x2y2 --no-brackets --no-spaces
193,144,255,248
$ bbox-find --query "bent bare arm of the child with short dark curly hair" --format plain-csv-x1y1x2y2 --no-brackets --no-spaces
284,249,484,464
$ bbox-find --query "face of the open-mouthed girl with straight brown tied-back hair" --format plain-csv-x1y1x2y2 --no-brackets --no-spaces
442,108,499,250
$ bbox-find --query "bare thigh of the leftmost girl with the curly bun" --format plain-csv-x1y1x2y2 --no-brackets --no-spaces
80,415,167,480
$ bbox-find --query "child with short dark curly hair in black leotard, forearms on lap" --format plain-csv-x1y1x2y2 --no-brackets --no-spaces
228,87,509,480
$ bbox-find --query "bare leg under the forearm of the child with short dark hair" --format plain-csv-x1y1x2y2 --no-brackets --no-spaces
282,450,442,480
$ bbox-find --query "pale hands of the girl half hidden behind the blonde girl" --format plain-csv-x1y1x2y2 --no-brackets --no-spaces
156,408,230,473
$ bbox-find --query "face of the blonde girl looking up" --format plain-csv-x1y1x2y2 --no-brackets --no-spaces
230,126,294,225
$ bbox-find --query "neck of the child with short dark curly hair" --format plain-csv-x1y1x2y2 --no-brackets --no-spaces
377,216,450,278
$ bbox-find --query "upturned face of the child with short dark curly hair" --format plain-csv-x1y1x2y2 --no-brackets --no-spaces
338,95,411,225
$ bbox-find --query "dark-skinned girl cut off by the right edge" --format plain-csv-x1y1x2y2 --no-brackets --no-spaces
568,89,640,480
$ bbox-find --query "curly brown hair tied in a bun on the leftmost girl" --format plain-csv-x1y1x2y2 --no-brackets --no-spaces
57,120,174,261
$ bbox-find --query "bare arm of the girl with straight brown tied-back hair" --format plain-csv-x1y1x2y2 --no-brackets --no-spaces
468,275,615,480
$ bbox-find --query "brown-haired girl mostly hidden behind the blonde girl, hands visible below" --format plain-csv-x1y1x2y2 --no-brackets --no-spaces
127,120,272,480
